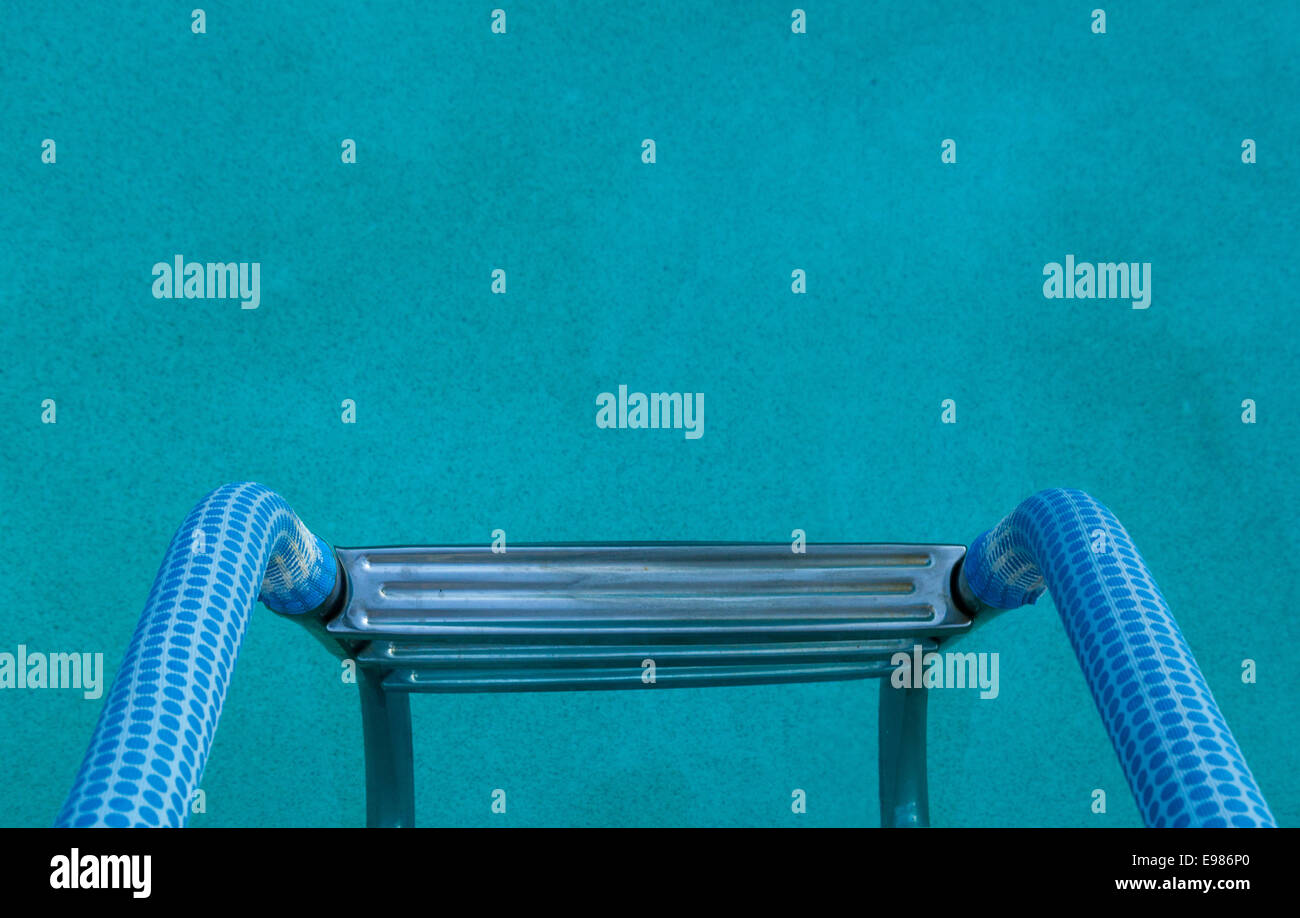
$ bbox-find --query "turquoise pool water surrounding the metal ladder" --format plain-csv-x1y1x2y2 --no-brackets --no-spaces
0,3,1300,827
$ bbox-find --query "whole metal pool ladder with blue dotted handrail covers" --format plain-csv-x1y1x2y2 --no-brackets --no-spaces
56,481,1277,827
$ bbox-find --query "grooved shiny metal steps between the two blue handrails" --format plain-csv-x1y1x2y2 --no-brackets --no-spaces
326,542,970,692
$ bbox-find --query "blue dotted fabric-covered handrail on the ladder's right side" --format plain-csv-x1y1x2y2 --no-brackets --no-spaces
965,489,1277,827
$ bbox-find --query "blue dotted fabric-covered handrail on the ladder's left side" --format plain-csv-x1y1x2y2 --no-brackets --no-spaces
56,481,337,827
